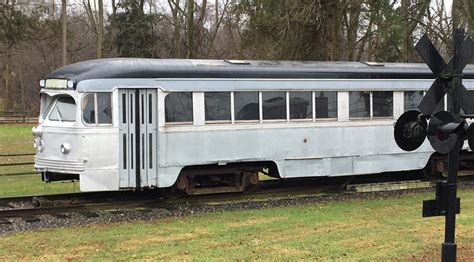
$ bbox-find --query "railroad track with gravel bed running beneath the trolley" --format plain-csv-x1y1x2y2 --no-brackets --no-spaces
0,178,474,227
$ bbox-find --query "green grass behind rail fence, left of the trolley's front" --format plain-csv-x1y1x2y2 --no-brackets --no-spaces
0,124,75,197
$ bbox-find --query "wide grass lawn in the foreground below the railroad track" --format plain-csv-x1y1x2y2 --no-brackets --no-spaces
0,189,474,261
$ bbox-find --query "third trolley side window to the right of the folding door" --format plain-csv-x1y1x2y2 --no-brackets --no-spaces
234,92,259,120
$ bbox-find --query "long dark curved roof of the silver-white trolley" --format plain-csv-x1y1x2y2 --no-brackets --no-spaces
46,58,474,82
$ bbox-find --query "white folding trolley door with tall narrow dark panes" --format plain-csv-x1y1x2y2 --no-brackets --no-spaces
118,89,157,188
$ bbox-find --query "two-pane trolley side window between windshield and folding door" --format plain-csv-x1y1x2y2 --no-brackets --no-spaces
82,93,112,125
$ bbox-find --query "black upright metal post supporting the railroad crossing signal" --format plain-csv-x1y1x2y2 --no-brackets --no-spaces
441,138,461,262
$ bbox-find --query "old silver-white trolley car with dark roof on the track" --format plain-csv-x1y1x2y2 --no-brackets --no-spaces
33,58,474,194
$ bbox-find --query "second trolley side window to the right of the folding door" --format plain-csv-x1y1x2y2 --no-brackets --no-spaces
204,92,230,121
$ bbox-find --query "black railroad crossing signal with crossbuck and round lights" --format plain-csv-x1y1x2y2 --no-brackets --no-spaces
394,29,474,261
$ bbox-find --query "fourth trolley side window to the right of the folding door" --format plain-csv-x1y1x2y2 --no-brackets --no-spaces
262,92,286,120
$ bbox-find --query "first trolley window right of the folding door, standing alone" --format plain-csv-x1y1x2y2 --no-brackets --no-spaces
165,92,193,122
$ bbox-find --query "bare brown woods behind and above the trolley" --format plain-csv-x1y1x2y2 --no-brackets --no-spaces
0,0,474,115
